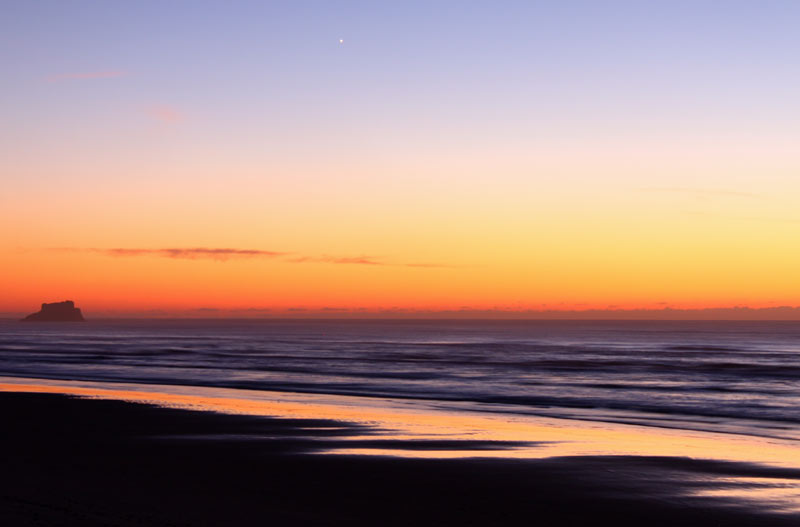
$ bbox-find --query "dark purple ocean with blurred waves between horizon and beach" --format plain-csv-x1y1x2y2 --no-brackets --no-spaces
0,320,800,439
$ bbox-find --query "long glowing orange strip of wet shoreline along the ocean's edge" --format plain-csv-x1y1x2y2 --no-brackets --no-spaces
0,376,800,464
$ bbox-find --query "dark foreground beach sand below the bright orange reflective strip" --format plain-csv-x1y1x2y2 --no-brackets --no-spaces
0,384,800,526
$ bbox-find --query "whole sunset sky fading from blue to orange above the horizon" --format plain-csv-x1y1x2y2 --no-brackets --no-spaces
0,0,800,315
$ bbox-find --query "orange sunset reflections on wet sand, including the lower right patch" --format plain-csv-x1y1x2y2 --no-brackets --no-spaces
0,378,800,512
